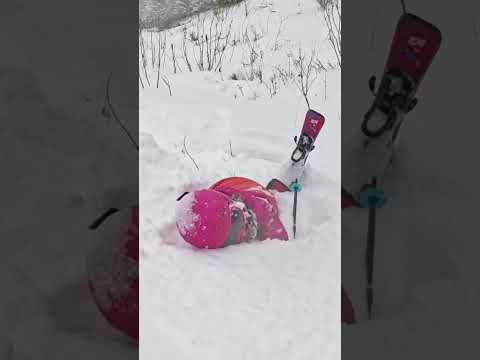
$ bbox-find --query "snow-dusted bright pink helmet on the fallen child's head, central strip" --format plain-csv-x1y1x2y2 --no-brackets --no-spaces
176,190,246,249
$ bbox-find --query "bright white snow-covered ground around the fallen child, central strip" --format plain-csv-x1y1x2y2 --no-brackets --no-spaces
139,0,341,360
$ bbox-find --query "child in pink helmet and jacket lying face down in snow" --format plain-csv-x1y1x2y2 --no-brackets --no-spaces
177,177,288,249
